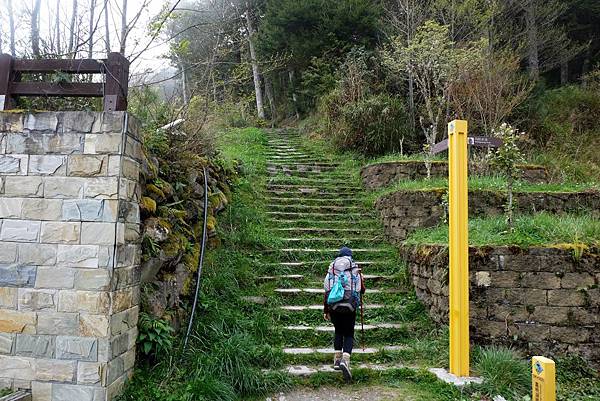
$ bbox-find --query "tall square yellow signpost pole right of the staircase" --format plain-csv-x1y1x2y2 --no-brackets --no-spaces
448,120,470,376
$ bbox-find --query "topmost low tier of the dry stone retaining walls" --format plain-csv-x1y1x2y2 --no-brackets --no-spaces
360,160,548,189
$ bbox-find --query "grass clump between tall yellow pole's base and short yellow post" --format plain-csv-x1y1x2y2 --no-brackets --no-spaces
474,347,531,401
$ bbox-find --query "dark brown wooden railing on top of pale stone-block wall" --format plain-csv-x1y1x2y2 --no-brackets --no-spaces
0,53,129,111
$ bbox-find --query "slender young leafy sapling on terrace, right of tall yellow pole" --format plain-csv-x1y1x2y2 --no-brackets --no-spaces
489,123,525,231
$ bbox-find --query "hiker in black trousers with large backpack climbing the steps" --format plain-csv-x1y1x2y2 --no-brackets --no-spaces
323,247,365,381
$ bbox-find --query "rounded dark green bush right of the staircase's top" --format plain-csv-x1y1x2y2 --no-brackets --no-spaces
327,94,411,156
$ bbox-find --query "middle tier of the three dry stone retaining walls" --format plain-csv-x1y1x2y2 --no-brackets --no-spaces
375,190,600,242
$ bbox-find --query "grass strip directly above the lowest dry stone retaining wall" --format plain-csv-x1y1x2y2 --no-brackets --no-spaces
406,213,600,247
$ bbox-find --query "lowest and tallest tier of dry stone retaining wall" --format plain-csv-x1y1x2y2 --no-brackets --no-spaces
402,245,600,366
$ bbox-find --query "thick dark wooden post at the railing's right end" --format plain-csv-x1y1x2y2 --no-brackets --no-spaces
104,53,129,111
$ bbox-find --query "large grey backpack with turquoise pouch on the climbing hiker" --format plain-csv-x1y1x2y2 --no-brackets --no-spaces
325,258,360,313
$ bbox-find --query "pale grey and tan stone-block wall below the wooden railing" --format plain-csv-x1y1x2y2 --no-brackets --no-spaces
0,112,142,401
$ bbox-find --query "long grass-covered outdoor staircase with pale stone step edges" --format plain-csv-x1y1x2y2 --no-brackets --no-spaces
255,130,426,376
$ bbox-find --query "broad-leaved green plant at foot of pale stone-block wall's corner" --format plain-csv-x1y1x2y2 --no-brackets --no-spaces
137,312,175,358
